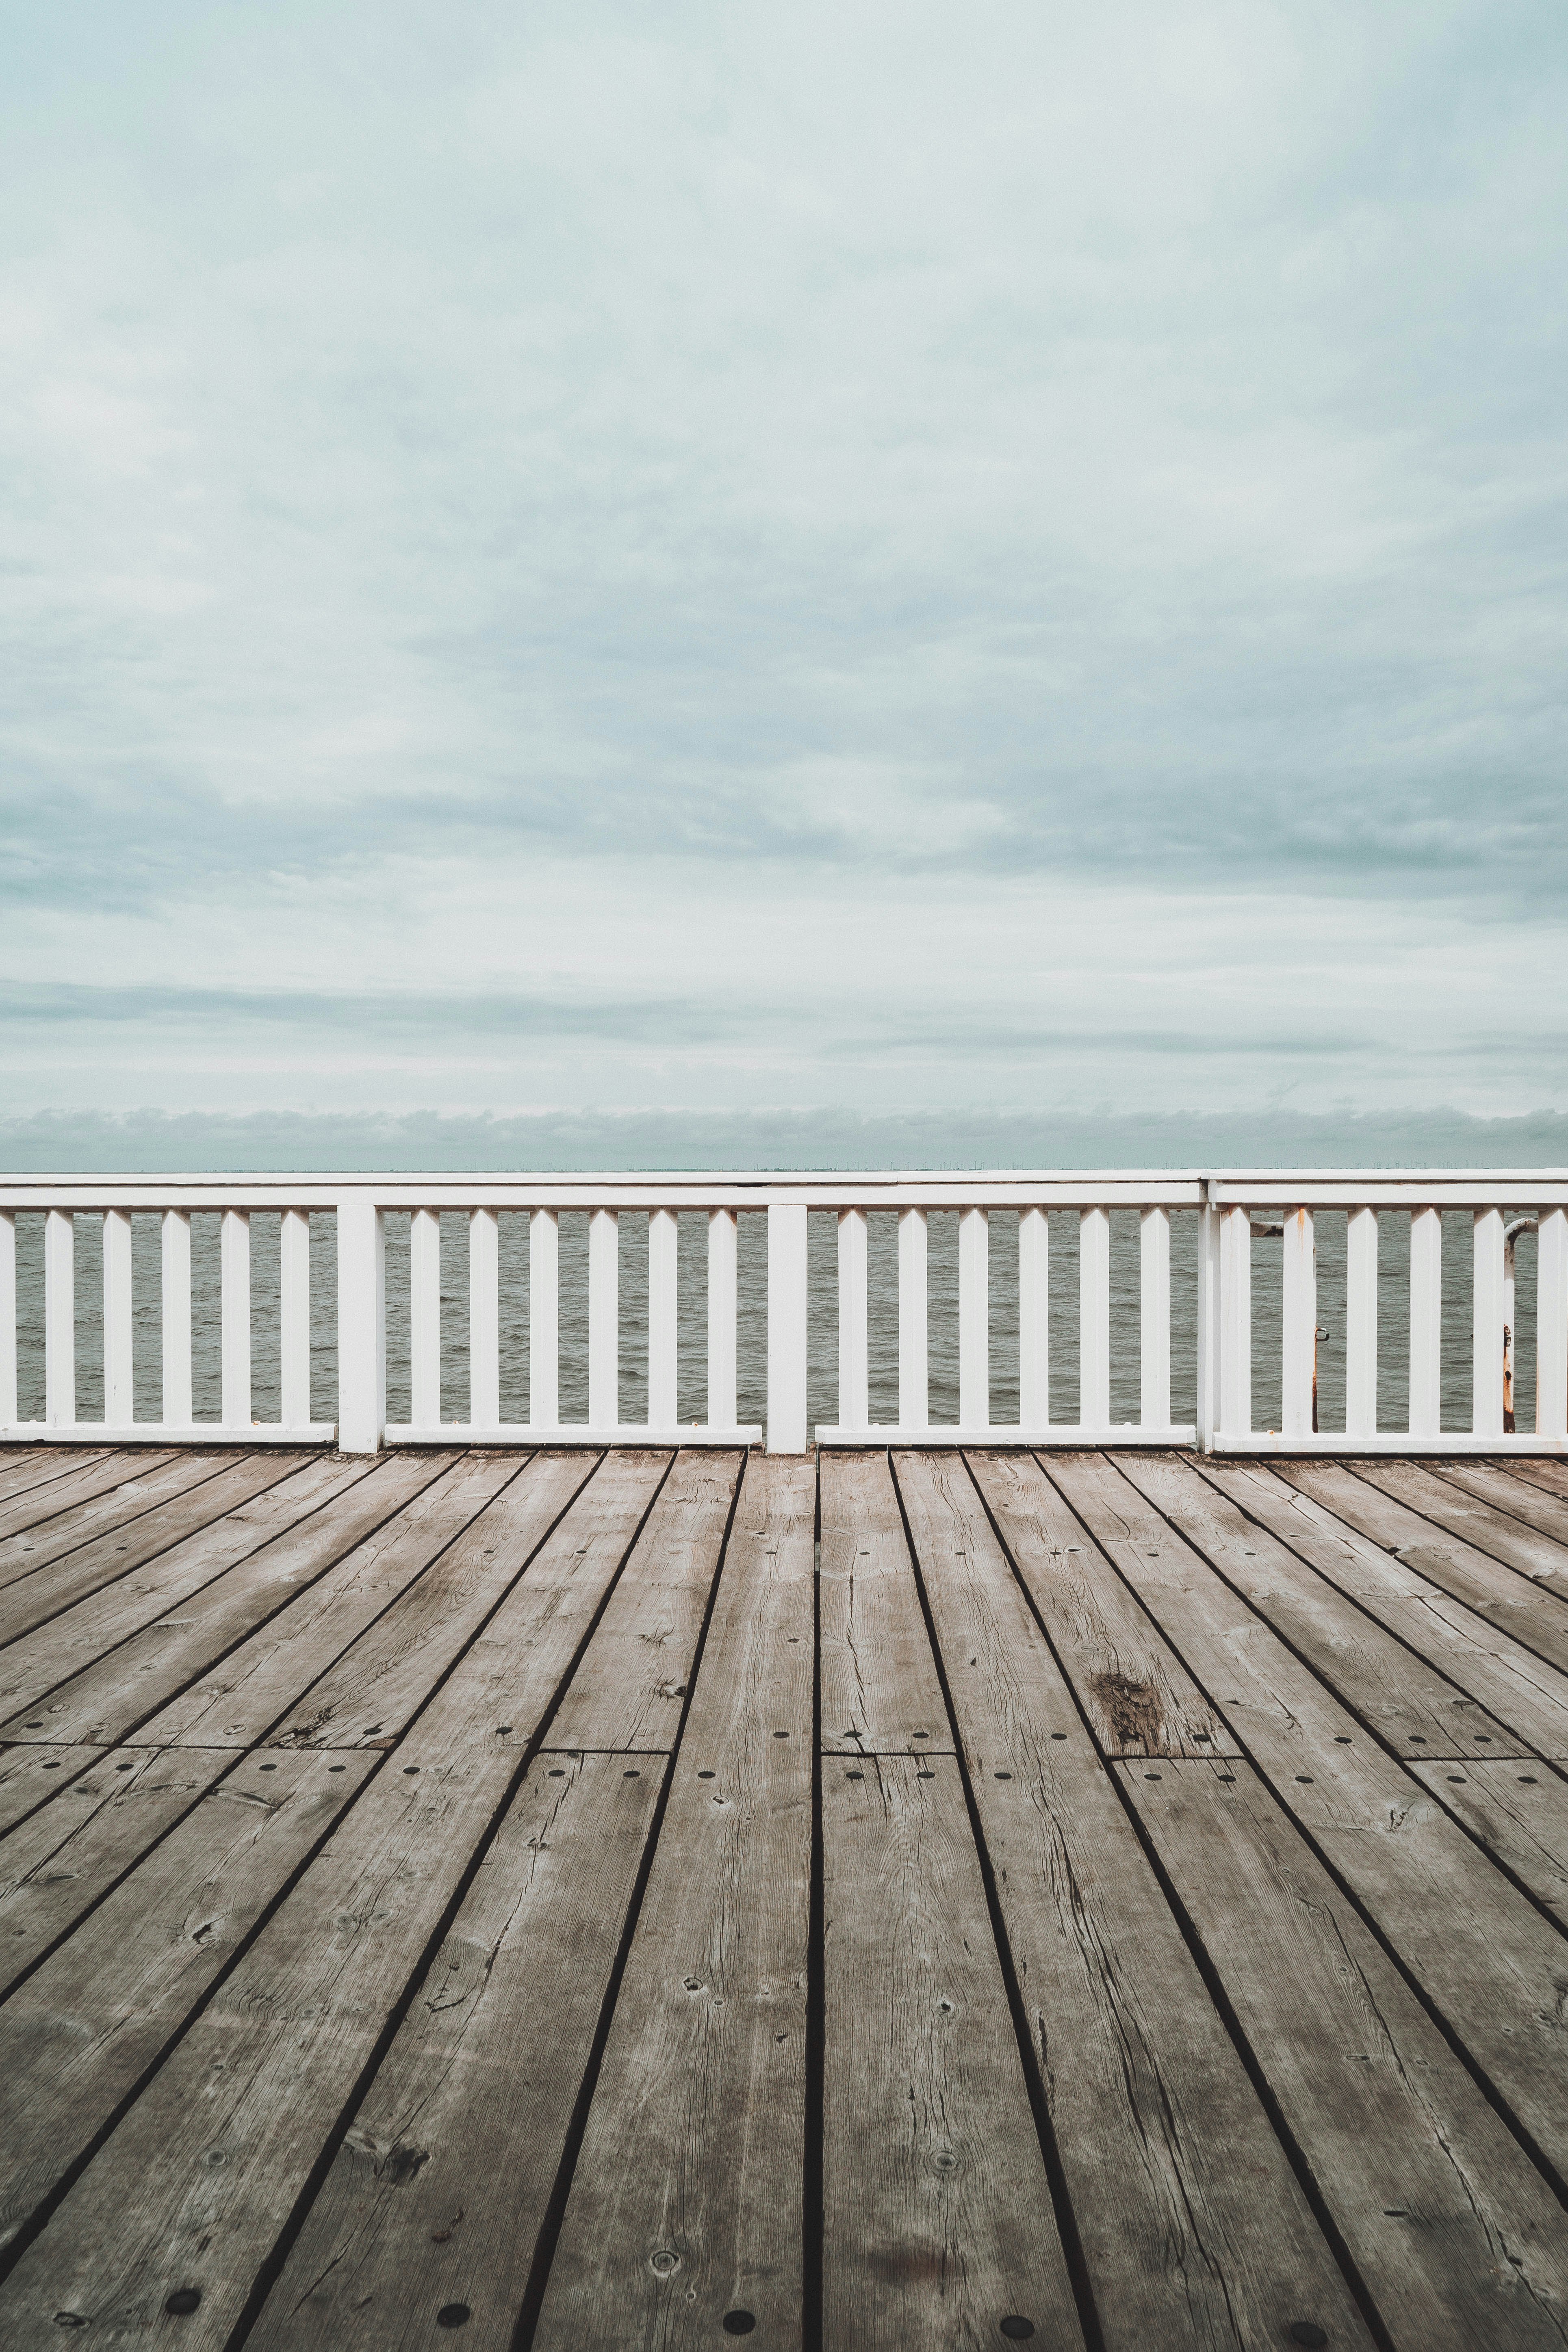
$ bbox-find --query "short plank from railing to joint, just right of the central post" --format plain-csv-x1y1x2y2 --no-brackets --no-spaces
818,1454,952,1755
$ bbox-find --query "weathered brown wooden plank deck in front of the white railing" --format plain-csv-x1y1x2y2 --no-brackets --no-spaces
0,1449,1568,2352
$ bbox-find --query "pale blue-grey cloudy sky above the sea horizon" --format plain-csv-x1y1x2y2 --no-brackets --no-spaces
0,0,1568,1157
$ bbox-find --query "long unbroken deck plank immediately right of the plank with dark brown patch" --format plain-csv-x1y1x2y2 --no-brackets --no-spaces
1053,1458,1568,2178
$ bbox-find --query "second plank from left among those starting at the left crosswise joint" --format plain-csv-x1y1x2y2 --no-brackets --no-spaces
0,1747,233,2002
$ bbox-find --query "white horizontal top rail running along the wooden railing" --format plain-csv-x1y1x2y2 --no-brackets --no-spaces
0,1169,1568,1211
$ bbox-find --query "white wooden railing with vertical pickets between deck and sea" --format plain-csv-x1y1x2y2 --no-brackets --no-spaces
0,1169,1568,1454
